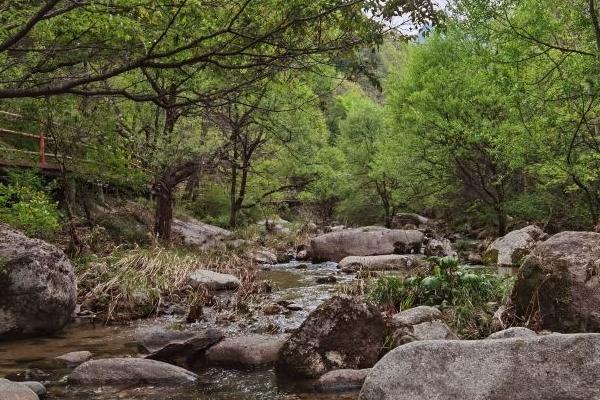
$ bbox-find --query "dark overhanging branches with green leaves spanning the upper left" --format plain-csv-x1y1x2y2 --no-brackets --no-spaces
0,0,435,101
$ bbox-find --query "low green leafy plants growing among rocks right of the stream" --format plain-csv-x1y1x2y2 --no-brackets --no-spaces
368,257,513,338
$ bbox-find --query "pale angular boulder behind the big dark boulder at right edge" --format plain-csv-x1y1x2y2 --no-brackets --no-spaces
483,225,546,267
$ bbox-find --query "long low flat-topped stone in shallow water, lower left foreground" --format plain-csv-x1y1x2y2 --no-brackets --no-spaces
68,358,198,385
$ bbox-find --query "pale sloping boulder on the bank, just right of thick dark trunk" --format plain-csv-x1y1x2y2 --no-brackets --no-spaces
171,218,232,249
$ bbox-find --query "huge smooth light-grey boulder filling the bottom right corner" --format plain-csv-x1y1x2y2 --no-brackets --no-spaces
359,334,600,400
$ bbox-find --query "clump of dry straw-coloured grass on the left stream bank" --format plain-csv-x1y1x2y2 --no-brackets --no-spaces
77,247,260,322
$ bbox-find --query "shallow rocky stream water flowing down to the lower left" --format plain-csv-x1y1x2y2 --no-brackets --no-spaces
0,262,358,400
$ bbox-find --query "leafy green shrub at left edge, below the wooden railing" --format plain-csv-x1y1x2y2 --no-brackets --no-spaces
0,171,60,238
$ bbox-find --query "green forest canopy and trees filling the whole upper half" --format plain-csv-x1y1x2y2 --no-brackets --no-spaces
0,0,600,241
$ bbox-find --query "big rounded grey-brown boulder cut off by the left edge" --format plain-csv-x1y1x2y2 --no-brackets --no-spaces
0,224,77,340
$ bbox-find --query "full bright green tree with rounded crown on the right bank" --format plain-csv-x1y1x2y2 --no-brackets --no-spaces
387,27,523,235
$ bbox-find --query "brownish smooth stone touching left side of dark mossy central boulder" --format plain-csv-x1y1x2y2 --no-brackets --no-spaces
206,335,287,368
